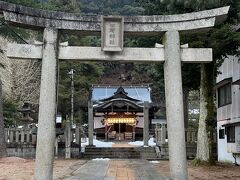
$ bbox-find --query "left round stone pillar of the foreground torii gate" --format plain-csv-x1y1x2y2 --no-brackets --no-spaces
34,28,58,180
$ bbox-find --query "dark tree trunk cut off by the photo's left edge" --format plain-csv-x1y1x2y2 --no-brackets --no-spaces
0,79,7,158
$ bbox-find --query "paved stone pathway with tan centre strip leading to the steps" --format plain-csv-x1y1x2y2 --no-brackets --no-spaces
65,159,170,180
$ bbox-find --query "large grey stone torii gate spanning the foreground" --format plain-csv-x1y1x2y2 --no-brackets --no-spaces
0,1,229,180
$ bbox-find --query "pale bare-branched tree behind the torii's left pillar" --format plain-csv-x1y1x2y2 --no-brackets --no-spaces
0,37,41,104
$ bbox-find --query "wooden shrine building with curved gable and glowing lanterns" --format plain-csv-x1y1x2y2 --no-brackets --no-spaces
90,85,153,141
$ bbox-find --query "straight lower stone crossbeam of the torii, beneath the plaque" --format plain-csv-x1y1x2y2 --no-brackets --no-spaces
7,44,212,63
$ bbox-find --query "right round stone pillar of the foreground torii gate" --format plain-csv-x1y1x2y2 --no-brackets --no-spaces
163,31,188,180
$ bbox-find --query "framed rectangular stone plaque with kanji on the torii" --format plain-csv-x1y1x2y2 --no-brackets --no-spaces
101,16,123,52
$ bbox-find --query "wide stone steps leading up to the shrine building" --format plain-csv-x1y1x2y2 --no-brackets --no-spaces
83,146,157,159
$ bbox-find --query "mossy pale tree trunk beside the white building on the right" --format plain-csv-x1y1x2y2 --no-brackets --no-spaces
196,63,215,164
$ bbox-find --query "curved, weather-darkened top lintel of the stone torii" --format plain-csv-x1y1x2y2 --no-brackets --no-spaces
0,1,229,35
